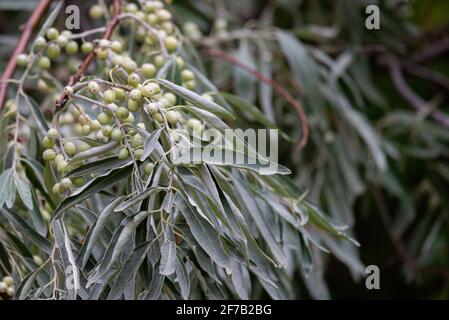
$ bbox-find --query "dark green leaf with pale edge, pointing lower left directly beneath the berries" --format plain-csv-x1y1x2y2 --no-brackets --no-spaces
52,166,132,220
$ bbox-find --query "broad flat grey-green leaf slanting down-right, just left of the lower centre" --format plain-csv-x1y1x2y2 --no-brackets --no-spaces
175,194,231,268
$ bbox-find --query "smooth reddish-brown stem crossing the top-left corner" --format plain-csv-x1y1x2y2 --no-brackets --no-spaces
0,0,52,110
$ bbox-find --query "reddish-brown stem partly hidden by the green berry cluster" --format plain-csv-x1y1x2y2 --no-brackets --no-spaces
56,0,121,109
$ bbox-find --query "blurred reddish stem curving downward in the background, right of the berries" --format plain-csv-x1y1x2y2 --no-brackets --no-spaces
203,49,309,148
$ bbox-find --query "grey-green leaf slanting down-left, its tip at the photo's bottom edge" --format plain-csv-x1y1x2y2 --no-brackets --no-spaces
108,241,152,300
